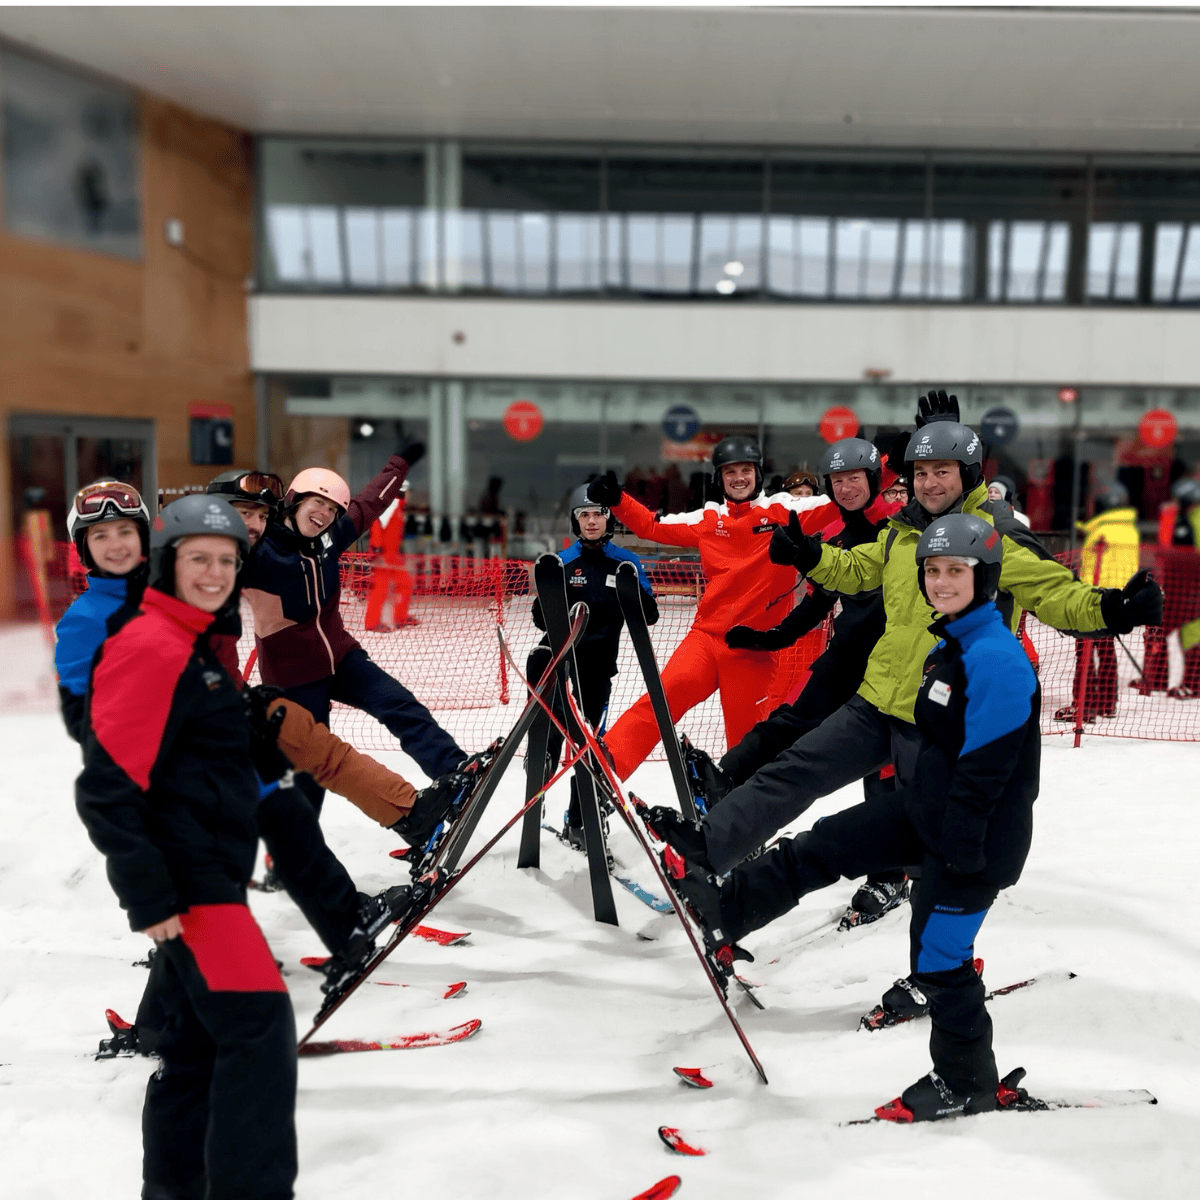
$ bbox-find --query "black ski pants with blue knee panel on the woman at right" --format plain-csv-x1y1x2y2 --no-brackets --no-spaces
721,791,1000,1094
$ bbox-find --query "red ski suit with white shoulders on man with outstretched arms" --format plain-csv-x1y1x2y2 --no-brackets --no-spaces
606,492,830,779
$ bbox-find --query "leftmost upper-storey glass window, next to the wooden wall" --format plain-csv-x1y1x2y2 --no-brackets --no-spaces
259,138,427,289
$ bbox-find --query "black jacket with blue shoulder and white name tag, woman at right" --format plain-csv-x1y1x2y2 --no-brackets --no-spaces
905,602,1042,888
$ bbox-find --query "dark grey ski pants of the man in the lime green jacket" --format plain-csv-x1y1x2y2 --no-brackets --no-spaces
704,696,920,874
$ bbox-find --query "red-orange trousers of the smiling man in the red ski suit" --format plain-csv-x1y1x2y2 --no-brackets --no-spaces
605,629,775,779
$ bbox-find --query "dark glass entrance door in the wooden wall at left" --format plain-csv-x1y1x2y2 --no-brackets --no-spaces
8,415,157,541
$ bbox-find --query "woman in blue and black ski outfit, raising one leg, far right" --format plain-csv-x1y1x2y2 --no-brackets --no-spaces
679,512,1042,1122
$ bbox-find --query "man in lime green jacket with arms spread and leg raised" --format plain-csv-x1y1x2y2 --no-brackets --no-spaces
648,403,1163,875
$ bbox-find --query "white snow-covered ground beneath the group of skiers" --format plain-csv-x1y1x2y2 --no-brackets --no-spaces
0,624,1200,1200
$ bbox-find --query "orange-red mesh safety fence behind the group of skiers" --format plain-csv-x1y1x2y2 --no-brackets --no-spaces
23,545,1200,755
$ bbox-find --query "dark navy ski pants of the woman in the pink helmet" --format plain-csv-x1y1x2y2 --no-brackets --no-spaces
283,646,467,814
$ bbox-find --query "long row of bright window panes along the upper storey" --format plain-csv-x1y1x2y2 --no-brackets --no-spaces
265,204,1200,304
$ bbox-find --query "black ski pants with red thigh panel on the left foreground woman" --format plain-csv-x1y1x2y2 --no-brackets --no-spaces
142,905,296,1200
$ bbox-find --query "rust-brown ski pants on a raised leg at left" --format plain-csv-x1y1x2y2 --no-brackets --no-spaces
270,698,416,826
